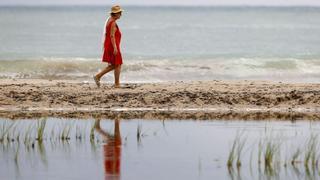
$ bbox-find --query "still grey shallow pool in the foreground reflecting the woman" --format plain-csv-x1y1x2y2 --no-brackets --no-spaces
0,118,320,179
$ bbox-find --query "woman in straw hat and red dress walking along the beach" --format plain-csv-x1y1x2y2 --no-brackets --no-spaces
93,5,123,88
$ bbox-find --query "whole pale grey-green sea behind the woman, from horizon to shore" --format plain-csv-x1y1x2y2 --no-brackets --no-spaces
0,6,320,83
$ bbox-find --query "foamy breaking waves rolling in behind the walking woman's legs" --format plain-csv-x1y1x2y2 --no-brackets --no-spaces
0,58,320,82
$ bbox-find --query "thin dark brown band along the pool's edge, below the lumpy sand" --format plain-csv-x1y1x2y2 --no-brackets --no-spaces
0,109,320,121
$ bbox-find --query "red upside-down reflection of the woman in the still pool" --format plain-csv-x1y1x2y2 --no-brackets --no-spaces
95,119,121,179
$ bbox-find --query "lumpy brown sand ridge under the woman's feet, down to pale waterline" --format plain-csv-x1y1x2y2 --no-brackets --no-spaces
0,79,320,118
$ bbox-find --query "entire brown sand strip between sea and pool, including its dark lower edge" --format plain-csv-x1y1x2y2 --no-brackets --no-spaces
0,79,320,120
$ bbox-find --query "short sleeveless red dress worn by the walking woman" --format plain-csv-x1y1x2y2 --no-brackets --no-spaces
102,20,122,65
